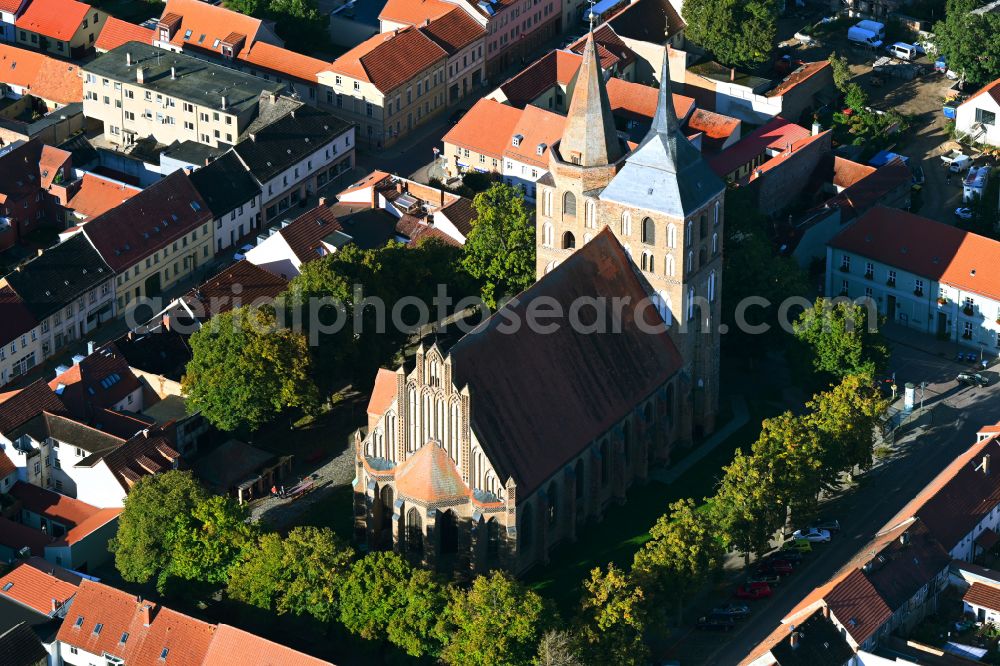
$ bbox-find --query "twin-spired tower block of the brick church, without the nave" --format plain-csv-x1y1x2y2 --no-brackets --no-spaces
536,35,725,442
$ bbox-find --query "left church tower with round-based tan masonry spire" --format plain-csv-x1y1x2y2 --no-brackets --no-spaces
535,33,626,277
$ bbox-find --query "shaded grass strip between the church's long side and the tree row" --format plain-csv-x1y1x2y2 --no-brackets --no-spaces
525,402,779,614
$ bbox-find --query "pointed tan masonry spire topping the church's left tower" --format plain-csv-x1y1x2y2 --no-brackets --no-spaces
559,33,622,167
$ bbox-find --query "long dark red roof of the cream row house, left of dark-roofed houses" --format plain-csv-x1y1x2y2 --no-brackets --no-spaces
82,170,212,273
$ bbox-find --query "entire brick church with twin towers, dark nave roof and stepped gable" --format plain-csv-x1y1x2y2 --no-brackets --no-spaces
354,36,724,578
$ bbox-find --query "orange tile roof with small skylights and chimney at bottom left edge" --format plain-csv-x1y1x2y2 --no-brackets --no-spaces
57,580,215,666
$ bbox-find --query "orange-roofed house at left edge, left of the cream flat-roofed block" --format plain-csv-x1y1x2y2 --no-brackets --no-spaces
0,44,83,108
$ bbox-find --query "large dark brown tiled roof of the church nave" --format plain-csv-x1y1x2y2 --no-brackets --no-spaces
450,229,682,493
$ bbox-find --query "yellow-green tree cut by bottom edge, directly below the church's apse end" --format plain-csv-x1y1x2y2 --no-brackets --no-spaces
441,571,551,666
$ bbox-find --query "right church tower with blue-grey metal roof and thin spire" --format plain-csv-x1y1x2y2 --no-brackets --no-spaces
599,52,725,434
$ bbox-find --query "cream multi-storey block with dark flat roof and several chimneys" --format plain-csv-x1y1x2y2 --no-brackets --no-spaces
83,42,284,148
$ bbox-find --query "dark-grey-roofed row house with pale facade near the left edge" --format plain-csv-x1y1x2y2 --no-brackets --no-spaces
0,235,117,383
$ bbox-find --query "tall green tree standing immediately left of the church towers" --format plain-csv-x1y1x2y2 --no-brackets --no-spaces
462,183,535,308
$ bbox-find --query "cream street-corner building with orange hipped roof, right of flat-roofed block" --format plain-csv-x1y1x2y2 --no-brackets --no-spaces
319,28,448,147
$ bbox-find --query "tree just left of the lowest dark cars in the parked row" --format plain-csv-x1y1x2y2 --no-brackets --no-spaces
632,499,725,623
